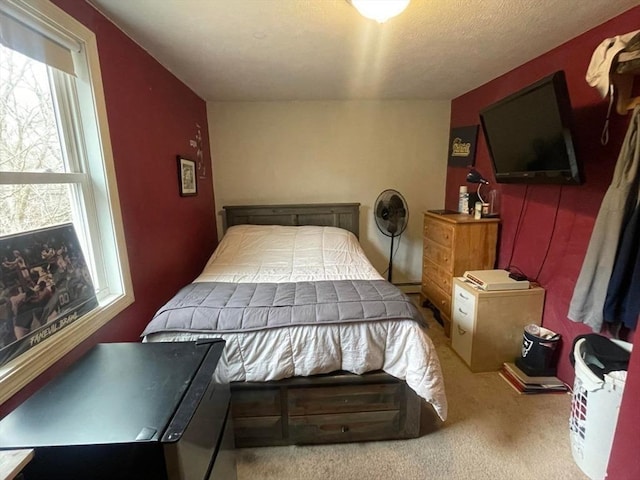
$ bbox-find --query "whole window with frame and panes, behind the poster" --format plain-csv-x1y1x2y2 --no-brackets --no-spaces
0,0,133,402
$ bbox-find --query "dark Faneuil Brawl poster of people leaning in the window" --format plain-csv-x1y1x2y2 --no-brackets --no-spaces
0,224,98,365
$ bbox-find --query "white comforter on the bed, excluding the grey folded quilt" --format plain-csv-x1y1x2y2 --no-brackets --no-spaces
145,225,447,420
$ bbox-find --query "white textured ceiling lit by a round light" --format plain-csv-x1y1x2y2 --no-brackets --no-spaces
89,0,638,101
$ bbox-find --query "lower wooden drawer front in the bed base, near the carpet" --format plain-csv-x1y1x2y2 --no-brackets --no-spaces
289,410,400,443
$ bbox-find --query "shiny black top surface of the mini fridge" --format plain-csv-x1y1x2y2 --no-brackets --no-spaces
0,342,222,450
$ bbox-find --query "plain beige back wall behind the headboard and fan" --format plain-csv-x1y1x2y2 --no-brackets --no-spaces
207,100,450,283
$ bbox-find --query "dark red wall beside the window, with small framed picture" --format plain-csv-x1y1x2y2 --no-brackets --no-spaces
0,0,217,416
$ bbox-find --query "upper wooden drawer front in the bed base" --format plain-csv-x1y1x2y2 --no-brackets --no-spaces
289,383,402,416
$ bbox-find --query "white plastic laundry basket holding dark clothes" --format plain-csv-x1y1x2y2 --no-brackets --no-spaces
569,339,633,480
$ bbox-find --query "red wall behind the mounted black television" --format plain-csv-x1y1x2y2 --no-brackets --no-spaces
445,7,640,479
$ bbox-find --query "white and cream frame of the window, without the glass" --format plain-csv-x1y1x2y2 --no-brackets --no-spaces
0,0,134,403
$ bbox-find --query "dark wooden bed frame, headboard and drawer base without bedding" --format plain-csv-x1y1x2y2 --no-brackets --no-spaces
223,203,423,447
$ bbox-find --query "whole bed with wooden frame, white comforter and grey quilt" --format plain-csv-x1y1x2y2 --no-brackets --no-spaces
143,203,447,447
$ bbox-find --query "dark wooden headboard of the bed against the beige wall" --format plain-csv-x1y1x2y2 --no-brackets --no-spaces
222,203,360,237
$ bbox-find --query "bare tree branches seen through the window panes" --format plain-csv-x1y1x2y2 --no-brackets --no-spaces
0,45,73,236
